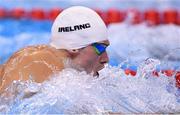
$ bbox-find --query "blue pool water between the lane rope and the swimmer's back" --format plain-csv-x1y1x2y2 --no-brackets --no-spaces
0,19,52,64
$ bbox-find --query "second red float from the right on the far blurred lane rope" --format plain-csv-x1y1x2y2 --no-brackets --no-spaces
144,9,160,25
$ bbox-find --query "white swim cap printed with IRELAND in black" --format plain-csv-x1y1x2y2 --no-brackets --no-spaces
50,6,108,49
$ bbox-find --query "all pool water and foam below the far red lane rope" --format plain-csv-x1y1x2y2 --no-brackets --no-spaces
0,19,180,114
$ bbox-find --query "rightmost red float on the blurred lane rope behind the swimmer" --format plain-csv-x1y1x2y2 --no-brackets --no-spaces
163,9,178,24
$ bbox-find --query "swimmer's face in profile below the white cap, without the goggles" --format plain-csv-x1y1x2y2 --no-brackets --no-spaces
71,40,109,75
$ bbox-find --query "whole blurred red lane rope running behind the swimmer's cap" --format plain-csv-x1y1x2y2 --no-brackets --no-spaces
0,7,180,25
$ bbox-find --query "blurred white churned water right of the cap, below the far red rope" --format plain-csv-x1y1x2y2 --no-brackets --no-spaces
108,23,180,66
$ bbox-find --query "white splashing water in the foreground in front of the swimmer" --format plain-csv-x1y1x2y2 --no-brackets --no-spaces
0,59,180,114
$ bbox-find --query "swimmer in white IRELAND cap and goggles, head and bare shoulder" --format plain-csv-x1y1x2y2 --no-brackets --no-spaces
0,6,109,92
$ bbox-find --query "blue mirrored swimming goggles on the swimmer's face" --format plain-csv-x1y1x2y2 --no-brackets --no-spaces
92,43,108,55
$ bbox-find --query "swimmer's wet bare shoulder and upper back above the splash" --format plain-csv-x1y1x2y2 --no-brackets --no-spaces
0,45,65,90
